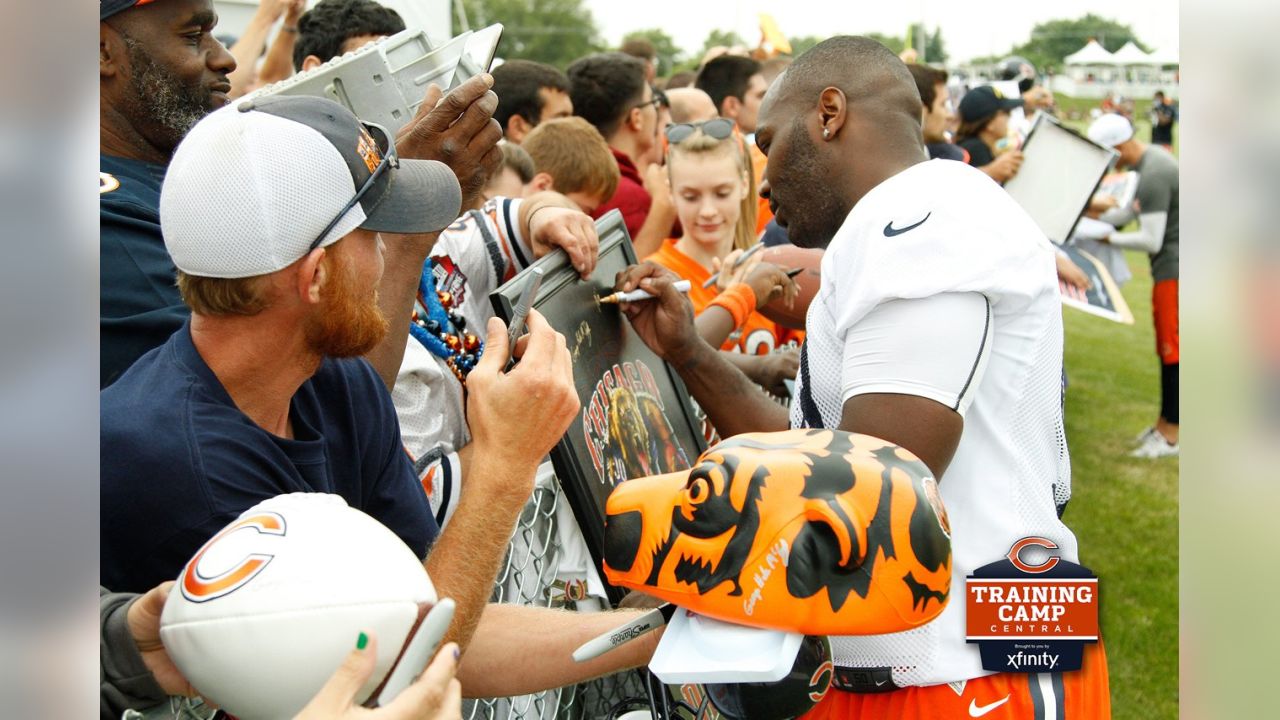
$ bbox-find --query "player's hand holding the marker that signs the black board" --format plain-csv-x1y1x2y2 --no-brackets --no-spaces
613,263,703,365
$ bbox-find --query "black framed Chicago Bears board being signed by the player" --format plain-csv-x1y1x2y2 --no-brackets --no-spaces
489,210,707,602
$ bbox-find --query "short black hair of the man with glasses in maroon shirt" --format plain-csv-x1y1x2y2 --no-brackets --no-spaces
566,53,645,140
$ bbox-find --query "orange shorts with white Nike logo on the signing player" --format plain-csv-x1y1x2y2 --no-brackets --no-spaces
803,643,1111,720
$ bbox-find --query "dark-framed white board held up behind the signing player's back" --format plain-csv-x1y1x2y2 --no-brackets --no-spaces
1005,113,1119,245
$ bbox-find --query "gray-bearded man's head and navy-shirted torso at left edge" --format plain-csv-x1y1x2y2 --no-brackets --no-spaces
99,0,236,387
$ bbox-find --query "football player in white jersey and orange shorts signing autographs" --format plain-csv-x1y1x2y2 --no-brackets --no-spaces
617,37,1110,719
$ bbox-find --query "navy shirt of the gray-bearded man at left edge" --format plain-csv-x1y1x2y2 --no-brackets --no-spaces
99,155,191,387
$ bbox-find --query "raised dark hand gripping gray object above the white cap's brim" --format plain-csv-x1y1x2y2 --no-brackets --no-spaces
396,73,502,208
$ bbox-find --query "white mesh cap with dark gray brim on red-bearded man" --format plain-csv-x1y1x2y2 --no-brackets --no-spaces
160,96,462,278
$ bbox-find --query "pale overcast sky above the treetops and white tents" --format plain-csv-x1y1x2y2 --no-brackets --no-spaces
586,0,1178,61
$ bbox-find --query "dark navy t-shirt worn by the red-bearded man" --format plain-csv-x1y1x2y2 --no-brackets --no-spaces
101,323,439,592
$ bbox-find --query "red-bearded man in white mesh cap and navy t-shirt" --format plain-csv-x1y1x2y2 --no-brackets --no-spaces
100,96,653,697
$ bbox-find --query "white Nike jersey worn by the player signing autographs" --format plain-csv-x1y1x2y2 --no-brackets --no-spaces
791,160,1078,685
